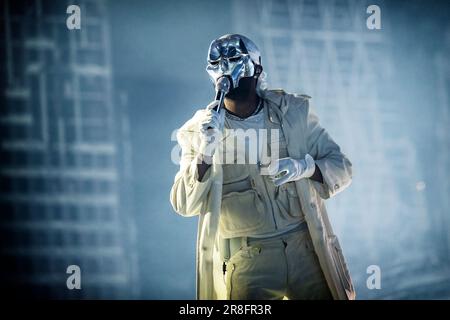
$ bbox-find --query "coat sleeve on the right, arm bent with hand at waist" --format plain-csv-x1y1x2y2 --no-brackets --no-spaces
305,100,352,199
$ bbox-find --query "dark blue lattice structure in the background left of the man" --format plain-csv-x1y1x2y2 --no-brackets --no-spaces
0,0,138,298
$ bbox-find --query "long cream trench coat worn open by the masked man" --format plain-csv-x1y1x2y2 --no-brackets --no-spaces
170,90,355,299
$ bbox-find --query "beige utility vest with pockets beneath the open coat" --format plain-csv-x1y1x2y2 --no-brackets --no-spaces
219,100,304,238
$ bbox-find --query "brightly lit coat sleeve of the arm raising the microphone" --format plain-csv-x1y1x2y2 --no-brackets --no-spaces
170,126,212,217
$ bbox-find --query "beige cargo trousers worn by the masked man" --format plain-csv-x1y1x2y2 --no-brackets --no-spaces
217,230,332,300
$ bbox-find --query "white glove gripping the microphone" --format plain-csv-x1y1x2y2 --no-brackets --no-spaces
198,101,225,157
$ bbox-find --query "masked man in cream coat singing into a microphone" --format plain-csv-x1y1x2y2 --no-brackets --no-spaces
170,34,355,299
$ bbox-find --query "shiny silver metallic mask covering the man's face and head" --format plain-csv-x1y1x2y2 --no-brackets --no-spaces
206,34,261,88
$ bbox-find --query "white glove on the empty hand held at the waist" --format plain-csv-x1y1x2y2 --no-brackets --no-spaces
268,154,316,186
